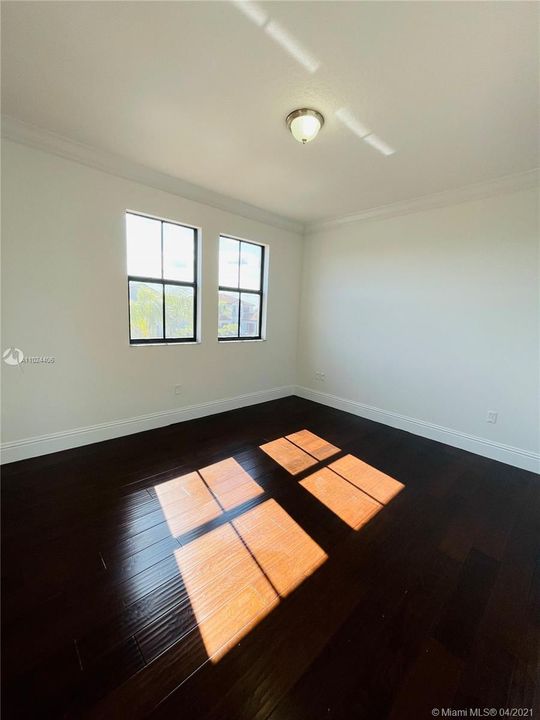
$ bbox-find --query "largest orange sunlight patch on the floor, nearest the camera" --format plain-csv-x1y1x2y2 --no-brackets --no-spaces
175,500,327,662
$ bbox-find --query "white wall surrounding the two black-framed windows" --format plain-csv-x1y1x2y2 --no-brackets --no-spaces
2,141,303,461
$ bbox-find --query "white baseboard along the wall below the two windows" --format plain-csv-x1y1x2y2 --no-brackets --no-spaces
0,385,295,464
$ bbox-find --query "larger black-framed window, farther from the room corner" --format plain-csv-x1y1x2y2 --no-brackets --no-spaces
126,213,197,345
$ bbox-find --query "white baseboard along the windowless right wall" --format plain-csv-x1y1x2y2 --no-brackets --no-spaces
295,386,540,473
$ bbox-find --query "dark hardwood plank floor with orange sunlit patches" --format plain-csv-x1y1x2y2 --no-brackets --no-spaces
2,397,540,720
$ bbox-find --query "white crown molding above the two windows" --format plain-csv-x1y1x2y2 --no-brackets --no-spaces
1,115,304,234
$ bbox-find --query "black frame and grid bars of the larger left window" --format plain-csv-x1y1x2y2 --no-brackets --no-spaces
125,210,199,345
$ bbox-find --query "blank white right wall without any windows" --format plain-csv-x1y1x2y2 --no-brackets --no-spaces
299,190,540,469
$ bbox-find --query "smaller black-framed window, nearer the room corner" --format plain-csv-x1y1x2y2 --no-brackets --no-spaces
218,235,264,340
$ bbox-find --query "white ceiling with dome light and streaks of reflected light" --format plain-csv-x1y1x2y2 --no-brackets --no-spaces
2,0,539,221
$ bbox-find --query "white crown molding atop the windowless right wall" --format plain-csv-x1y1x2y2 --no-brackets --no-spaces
304,168,540,234
